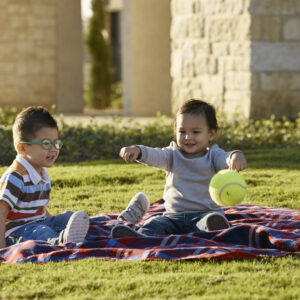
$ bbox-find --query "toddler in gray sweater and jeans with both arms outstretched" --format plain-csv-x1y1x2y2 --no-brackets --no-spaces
112,99,247,238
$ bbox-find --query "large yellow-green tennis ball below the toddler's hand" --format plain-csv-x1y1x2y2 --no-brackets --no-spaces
209,170,246,206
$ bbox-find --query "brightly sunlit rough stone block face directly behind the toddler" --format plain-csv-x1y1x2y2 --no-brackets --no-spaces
171,0,252,115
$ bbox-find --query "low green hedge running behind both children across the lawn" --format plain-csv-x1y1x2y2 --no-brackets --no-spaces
0,114,300,165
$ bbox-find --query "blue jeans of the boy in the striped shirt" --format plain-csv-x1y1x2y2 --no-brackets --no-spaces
6,210,73,246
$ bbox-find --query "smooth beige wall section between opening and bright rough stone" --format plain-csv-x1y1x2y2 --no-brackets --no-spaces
122,0,171,116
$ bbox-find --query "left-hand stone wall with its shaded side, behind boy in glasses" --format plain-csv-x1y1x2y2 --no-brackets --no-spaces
0,0,83,112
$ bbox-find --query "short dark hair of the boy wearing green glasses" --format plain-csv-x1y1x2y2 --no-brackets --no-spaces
13,106,58,148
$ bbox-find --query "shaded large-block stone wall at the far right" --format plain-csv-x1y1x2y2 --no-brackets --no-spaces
249,0,300,117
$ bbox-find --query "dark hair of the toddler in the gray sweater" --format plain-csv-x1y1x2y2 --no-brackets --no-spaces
175,99,218,130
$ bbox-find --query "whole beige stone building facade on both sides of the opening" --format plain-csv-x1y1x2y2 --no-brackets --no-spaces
0,0,300,118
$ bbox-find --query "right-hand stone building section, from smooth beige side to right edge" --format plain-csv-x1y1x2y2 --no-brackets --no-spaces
122,0,300,118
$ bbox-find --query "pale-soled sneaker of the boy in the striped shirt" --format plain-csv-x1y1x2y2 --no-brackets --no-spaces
58,211,90,244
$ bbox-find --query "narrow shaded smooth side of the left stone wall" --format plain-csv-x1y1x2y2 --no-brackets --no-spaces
56,0,84,113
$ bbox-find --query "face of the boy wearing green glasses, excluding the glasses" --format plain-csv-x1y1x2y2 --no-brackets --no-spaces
17,127,59,173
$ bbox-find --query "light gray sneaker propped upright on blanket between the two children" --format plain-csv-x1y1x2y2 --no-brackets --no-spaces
118,193,150,224
